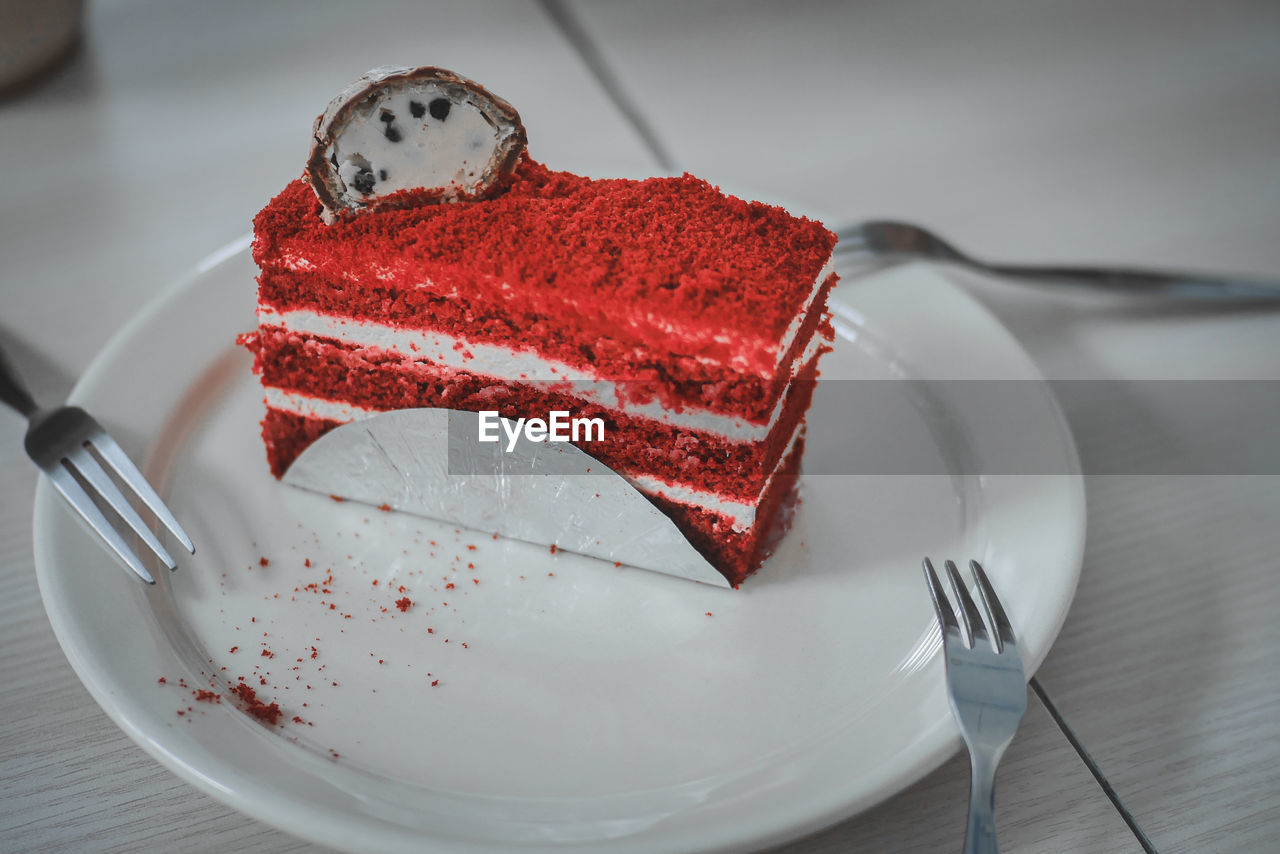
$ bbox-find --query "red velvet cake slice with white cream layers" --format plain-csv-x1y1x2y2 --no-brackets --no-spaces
250,69,836,585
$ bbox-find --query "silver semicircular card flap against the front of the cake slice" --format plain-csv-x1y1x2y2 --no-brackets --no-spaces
284,408,730,588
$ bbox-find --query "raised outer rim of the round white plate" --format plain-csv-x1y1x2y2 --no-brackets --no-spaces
32,236,1085,851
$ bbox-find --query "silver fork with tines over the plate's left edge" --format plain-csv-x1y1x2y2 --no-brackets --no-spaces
0,351,196,584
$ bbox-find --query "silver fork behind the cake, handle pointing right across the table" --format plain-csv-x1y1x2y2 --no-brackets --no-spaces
836,220,1280,301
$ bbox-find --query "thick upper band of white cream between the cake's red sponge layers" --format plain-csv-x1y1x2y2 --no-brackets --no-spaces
257,300,823,442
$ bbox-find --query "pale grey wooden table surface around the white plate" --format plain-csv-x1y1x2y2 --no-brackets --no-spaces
0,0,1280,853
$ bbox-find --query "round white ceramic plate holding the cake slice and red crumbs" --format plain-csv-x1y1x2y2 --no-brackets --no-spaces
35,243,1084,851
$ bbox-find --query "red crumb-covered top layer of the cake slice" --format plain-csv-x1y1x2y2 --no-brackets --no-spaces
253,160,836,373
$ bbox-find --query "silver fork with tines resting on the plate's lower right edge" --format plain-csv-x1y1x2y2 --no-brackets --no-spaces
924,558,1027,854
